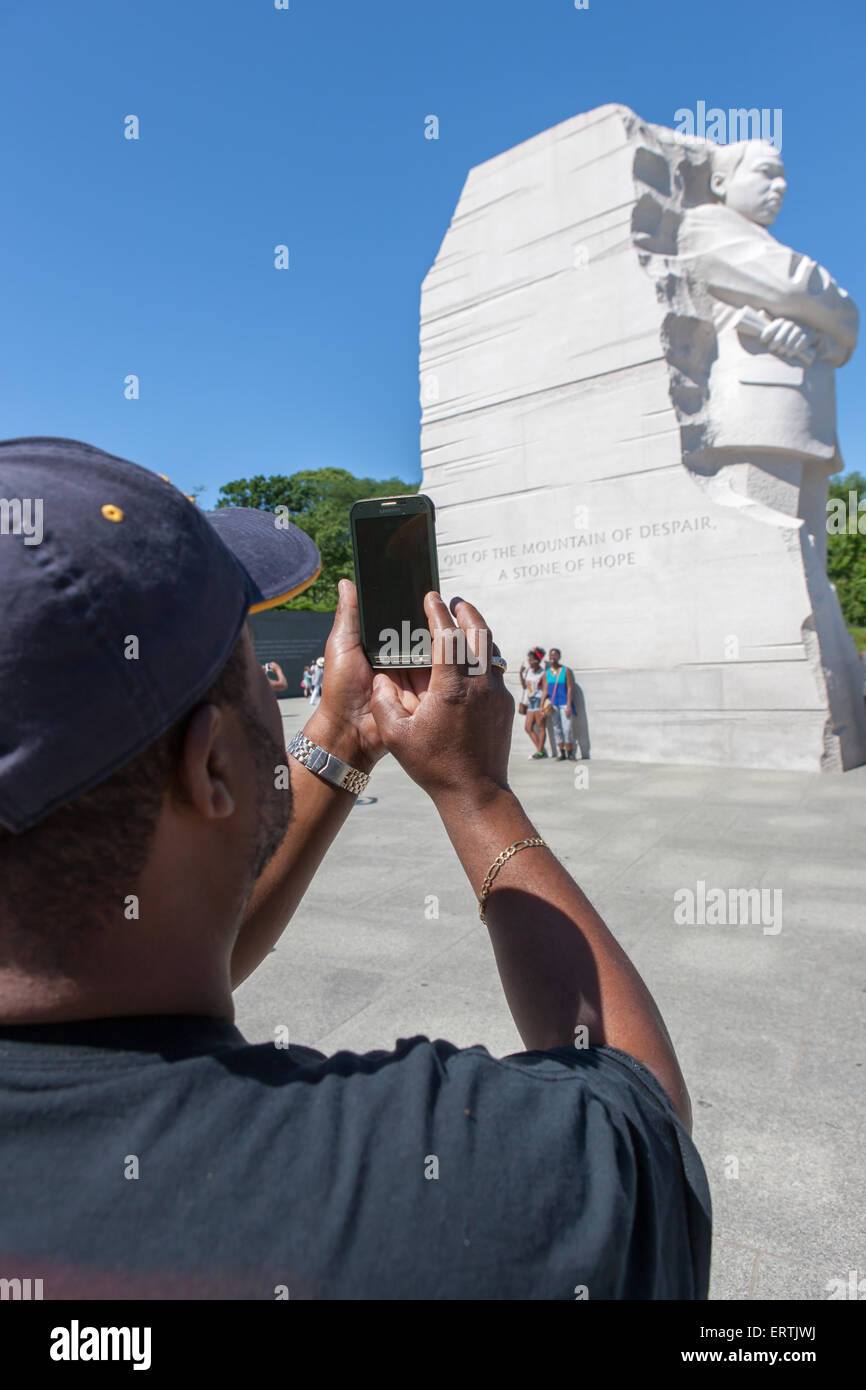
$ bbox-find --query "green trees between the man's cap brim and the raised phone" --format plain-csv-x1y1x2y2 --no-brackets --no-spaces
217,468,420,612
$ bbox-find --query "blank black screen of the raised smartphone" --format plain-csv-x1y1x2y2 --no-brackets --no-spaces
354,512,436,656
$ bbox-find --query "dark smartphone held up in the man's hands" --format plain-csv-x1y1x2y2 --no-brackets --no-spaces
349,492,439,671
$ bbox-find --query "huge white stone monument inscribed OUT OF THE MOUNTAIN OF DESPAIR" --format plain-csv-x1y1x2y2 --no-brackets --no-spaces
421,106,866,771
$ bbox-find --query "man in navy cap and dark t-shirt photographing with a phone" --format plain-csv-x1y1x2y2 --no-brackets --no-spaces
0,439,710,1300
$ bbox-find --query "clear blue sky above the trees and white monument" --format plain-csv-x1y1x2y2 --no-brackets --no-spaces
0,0,866,506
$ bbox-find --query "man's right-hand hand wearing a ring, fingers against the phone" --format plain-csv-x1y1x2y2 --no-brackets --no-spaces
373,592,514,801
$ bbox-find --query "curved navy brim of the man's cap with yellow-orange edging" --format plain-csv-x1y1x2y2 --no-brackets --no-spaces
204,507,321,613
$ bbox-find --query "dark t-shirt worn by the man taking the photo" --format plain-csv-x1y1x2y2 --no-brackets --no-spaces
0,1017,710,1300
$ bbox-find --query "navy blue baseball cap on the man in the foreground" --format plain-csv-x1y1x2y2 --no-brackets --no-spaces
0,439,321,834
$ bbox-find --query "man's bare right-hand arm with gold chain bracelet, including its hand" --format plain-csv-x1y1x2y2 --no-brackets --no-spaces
373,594,691,1129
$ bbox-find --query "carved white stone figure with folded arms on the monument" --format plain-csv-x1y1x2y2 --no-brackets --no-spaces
678,140,858,536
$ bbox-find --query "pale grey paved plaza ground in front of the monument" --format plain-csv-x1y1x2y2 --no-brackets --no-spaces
235,699,866,1300
